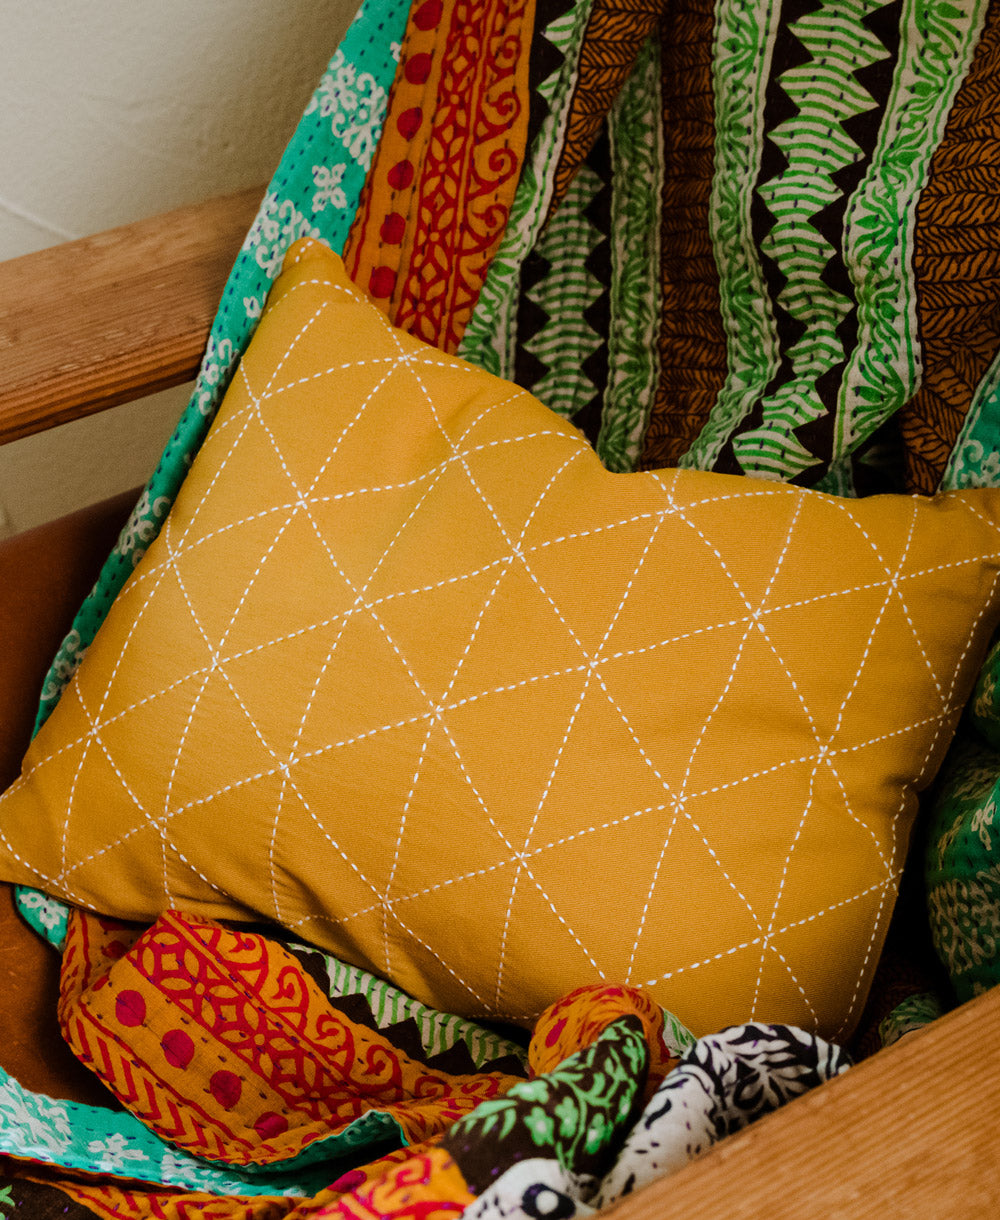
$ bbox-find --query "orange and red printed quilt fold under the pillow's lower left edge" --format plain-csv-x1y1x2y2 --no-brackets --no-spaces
60,913,526,1165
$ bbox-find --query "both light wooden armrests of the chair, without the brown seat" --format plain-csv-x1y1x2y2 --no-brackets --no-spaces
0,189,1000,1220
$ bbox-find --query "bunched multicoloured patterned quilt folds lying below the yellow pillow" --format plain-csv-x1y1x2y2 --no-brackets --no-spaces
0,913,849,1220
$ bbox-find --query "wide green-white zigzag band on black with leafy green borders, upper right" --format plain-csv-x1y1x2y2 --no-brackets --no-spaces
702,2,985,492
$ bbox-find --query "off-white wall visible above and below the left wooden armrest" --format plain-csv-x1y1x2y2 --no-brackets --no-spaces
0,0,357,534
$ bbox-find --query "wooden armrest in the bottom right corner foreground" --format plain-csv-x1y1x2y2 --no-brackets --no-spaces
611,988,1000,1220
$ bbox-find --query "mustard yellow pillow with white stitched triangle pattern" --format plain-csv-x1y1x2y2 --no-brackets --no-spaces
0,243,1000,1037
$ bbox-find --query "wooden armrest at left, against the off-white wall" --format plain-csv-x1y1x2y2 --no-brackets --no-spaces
0,187,263,444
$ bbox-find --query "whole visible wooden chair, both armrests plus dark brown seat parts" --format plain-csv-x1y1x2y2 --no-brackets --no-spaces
0,190,1000,1220
